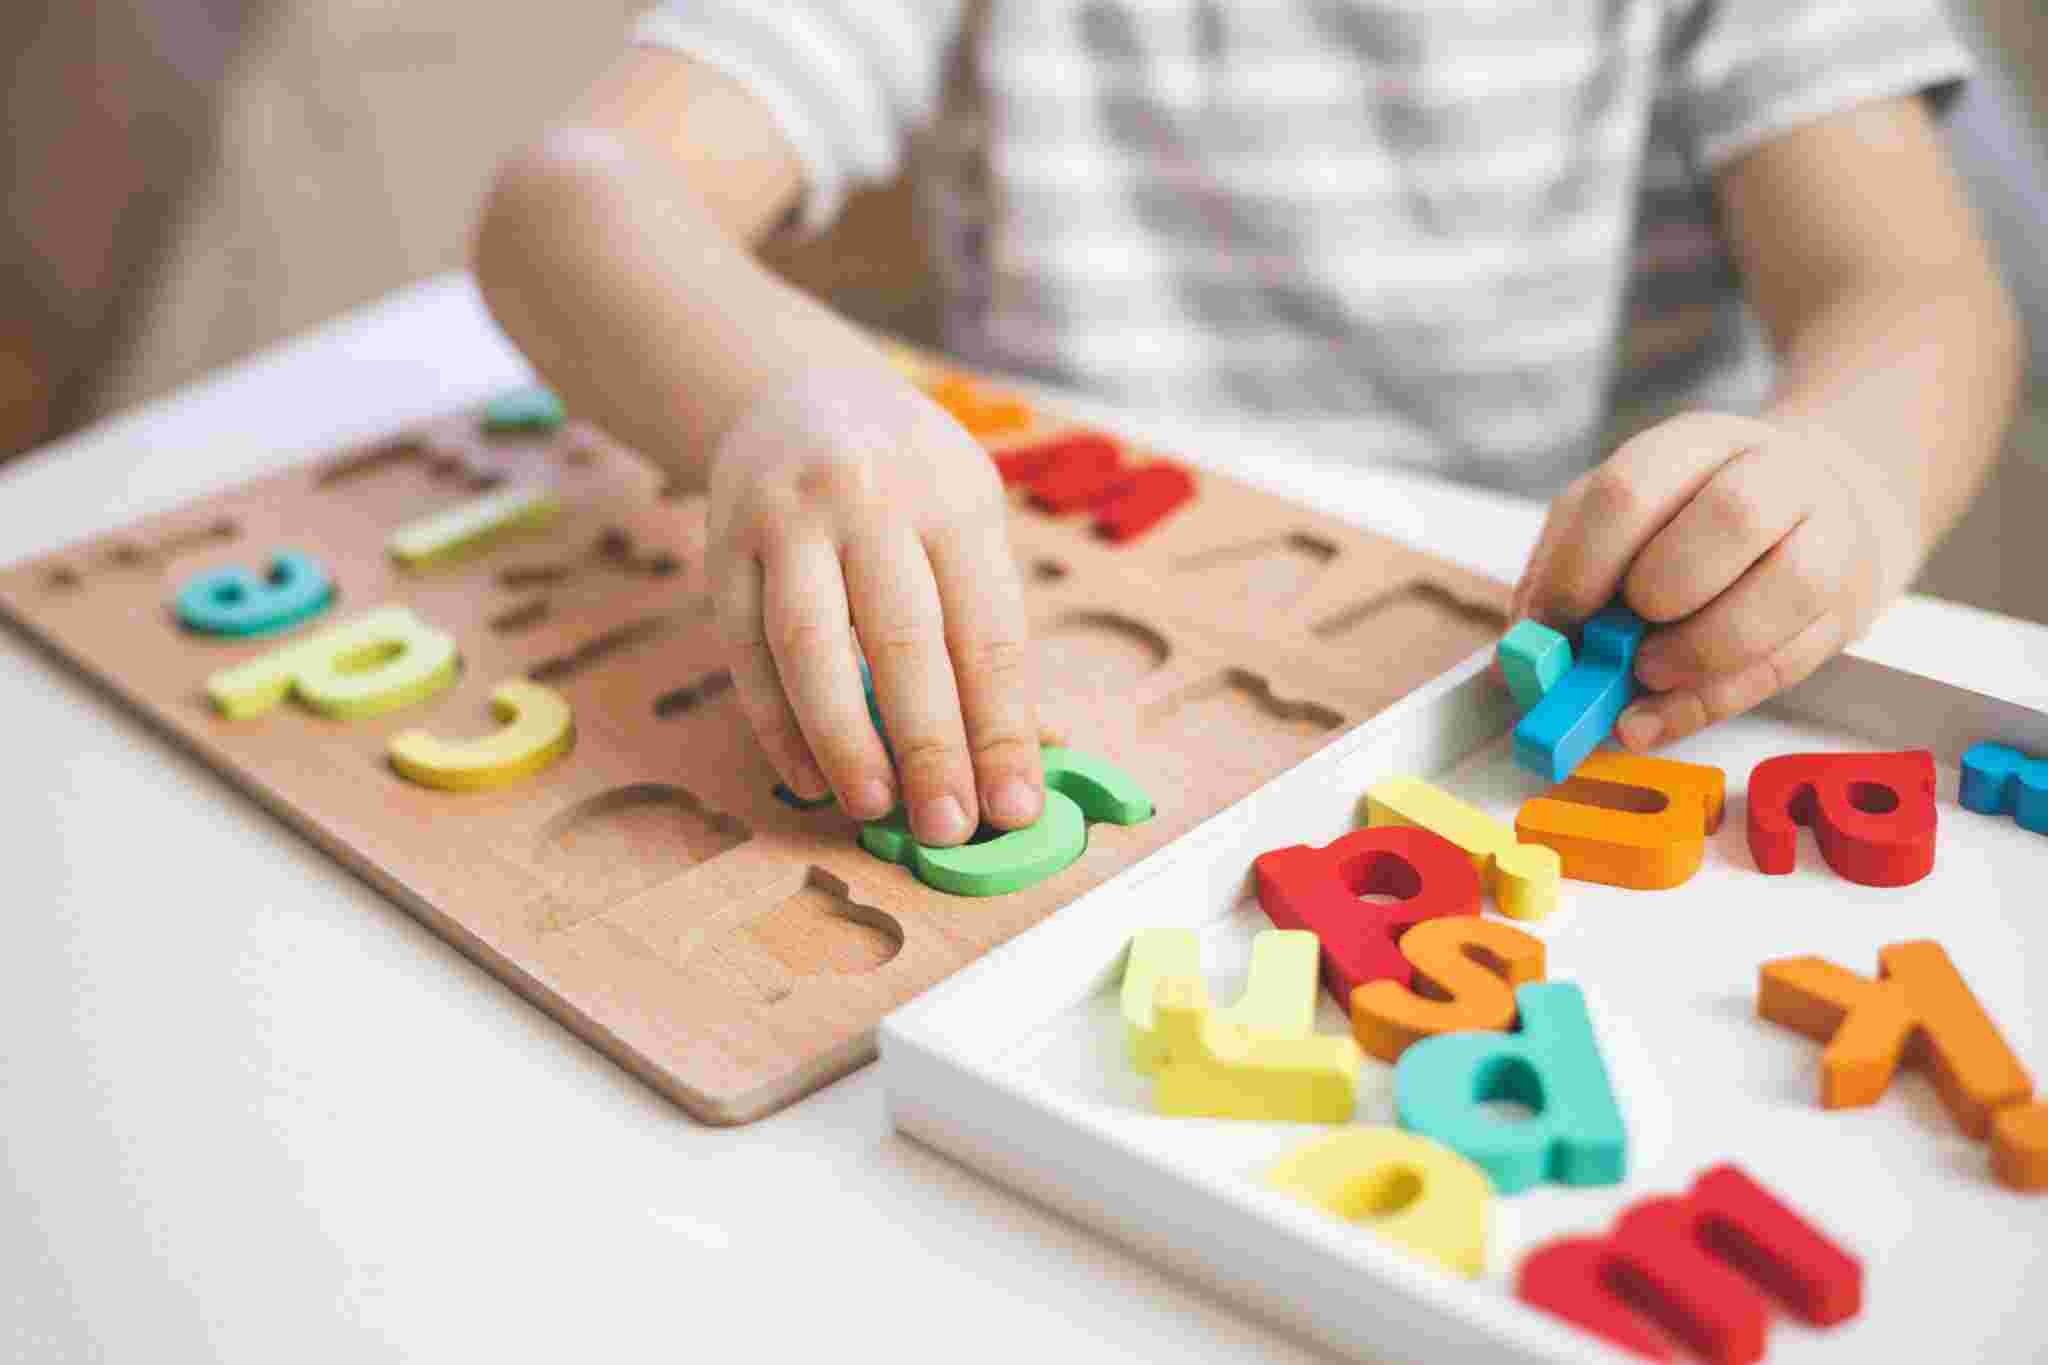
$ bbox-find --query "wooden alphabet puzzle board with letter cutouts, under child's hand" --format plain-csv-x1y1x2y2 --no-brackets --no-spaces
0,358,1505,1124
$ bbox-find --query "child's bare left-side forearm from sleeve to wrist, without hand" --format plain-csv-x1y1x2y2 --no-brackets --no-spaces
475,60,883,497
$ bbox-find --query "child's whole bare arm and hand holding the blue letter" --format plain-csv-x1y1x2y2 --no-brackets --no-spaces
1513,98,2019,749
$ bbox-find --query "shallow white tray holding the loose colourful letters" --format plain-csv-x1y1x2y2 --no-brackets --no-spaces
881,655,2048,1365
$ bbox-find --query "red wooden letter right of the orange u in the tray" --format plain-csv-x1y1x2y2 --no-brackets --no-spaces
1749,749,1935,886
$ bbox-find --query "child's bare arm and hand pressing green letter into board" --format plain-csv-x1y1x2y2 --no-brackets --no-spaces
475,51,1042,845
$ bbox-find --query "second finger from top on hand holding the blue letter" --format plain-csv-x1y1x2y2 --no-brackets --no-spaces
1624,446,1812,622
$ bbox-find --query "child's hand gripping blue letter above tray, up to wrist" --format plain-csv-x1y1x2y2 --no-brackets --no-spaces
1509,413,1921,751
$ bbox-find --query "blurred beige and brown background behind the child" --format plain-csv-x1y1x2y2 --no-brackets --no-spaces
0,0,2048,620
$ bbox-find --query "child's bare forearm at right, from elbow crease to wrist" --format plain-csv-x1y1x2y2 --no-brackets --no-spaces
1765,268,2021,598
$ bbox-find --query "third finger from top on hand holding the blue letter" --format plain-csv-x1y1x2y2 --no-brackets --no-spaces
1636,526,1835,692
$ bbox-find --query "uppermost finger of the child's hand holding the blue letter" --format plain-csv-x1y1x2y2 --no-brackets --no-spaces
1528,415,1743,626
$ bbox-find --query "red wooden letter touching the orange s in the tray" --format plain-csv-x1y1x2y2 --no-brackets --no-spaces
1251,825,1479,1009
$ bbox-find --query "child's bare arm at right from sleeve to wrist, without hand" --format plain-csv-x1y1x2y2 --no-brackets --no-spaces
1718,96,2019,598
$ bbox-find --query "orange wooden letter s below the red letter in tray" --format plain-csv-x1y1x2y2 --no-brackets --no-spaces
1352,915,1544,1062
